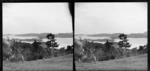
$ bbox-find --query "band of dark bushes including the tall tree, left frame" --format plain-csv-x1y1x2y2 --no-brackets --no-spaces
3,34,73,62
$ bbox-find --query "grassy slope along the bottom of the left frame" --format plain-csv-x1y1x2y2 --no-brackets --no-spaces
3,54,73,71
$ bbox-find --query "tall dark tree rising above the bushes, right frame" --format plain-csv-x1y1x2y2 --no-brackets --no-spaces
118,33,131,57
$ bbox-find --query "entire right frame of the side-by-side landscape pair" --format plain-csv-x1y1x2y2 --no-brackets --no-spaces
74,2,148,71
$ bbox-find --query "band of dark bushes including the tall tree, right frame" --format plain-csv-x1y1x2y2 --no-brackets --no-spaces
74,34,147,62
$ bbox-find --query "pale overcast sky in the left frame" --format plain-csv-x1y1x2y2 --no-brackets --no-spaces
3,3,72,34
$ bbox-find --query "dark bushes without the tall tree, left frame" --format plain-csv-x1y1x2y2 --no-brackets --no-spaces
3,37,72,62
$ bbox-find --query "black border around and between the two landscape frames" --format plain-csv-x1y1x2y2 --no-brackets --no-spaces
0,0,150,71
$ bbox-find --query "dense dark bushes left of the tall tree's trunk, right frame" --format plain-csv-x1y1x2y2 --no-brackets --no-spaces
75,41,130,62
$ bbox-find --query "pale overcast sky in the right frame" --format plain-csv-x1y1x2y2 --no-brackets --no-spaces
75,2,147,34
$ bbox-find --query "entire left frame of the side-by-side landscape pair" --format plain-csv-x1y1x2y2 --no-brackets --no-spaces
2,2,73,71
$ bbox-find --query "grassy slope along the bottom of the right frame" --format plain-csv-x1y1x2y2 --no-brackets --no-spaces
76,54,148,71
